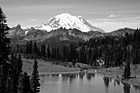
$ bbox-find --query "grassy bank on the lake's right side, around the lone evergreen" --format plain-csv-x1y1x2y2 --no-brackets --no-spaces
88,65,140,86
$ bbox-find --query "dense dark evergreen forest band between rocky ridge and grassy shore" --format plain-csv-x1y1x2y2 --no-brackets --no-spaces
20,29,140,78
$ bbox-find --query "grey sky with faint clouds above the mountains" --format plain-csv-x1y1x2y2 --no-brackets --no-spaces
0,0,140,32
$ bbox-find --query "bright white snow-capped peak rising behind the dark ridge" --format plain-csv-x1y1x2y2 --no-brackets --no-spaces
35,13,104,32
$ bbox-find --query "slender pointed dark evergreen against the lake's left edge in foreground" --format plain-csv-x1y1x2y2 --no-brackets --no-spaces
30,58,40,93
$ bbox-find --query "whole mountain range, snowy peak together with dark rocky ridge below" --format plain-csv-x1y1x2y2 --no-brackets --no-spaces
8,14,135,43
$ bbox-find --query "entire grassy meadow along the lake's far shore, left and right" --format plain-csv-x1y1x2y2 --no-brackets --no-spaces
23,58,140,87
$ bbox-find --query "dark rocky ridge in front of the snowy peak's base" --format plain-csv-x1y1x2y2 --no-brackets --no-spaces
9,25,135,42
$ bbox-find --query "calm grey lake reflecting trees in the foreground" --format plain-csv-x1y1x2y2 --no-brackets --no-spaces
40,72,140,93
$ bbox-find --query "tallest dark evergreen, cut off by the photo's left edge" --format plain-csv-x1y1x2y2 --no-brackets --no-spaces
0,7,10,93
